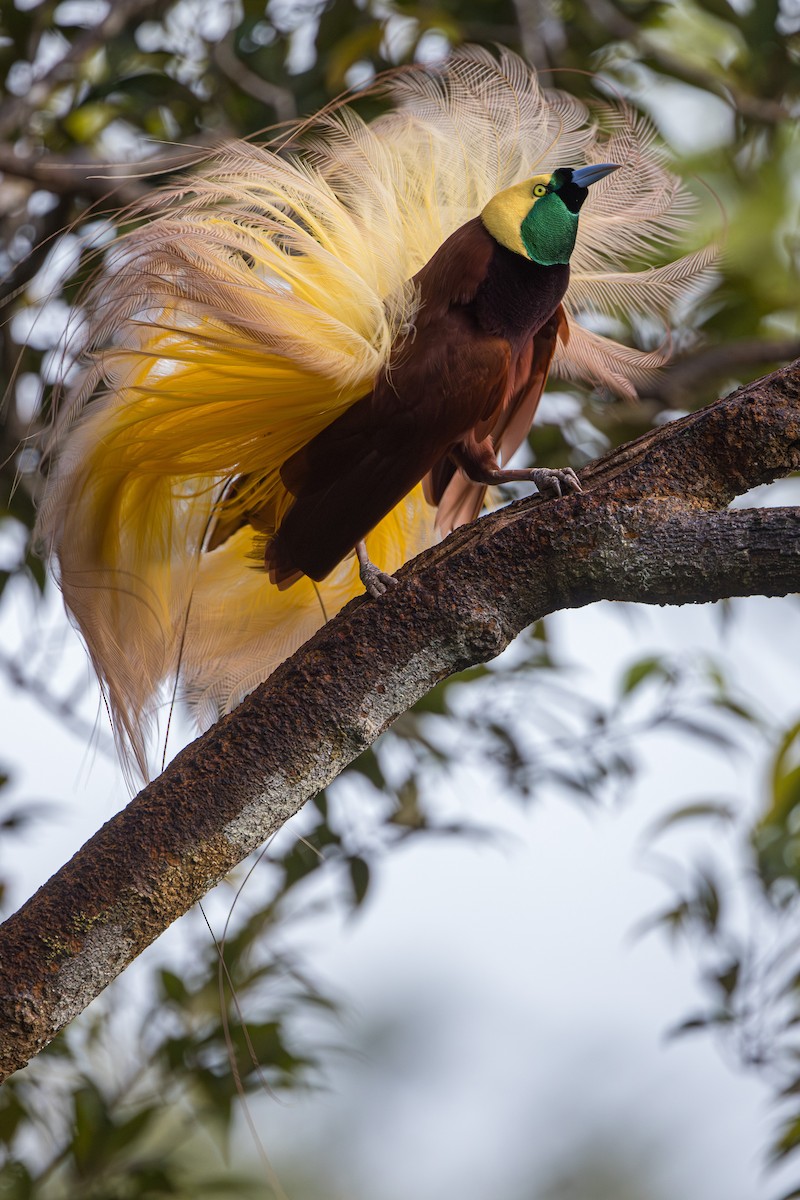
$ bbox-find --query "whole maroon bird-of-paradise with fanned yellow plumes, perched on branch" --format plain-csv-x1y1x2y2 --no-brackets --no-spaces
38,48,711,774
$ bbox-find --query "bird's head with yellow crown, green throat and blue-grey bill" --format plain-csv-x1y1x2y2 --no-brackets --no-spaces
481,162,619,266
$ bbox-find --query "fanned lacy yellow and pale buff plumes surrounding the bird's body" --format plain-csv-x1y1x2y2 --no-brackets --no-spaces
38,48,710,774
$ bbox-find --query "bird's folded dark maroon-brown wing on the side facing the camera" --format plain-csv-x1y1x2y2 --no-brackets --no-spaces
265,218,511,586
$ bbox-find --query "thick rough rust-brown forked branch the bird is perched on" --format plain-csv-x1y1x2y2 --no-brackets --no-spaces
0,362,800,1078
